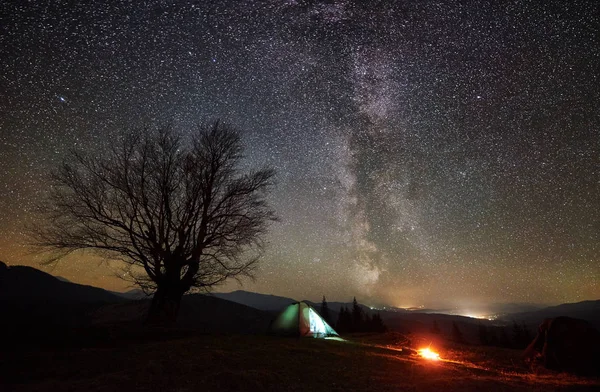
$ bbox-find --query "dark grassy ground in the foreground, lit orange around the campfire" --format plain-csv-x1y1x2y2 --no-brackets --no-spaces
0,333,600,392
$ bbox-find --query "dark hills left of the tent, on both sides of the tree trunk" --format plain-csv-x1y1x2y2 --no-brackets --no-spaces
0,262,273,334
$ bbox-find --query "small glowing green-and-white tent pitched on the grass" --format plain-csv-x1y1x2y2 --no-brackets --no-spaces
269,302,338,338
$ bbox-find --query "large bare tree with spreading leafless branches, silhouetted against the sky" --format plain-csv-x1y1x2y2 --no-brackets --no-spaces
34,121,276,323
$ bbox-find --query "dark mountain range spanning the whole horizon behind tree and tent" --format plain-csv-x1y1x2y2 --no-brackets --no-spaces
0,262,600,332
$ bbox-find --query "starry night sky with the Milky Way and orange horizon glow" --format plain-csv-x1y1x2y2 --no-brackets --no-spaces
0,0,600,308
